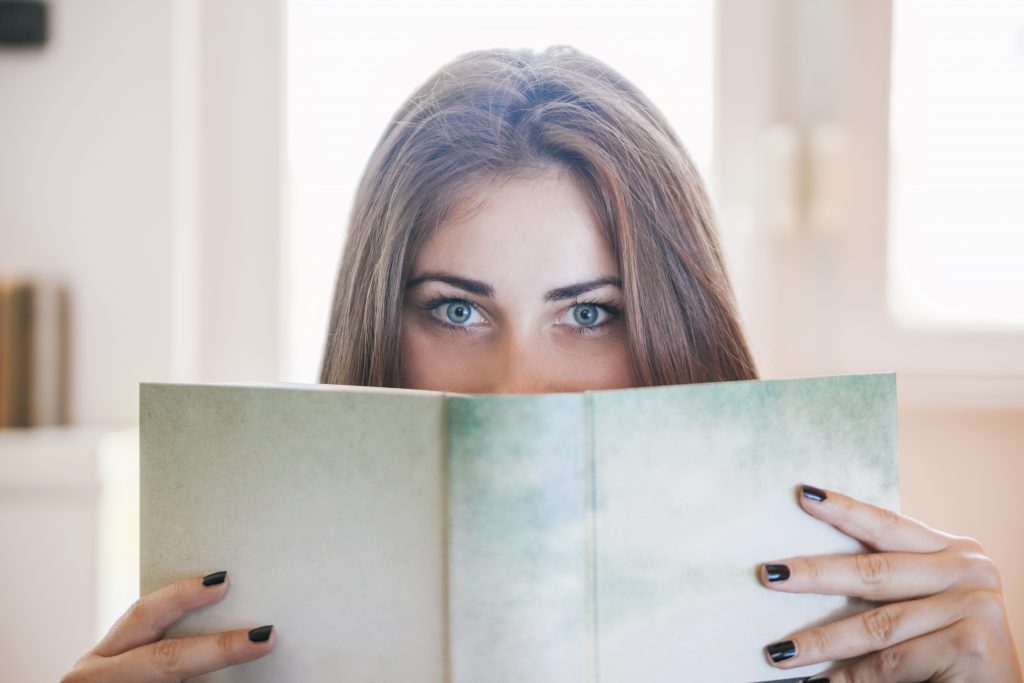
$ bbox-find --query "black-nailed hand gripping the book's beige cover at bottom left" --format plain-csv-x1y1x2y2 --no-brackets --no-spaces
61,571,276,683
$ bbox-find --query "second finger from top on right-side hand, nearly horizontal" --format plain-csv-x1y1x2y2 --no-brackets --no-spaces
761,552,972,601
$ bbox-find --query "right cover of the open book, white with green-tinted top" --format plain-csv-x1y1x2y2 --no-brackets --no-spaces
588,375,899,683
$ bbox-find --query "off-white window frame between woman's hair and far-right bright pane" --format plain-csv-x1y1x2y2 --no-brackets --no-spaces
715,0,1024,409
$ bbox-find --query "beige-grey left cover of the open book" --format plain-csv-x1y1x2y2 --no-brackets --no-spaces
140,384,446,683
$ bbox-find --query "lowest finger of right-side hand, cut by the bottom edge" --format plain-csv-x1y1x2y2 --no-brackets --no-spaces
823,622,975,683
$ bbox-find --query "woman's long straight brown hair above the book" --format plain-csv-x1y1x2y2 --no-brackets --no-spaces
321,46,757,386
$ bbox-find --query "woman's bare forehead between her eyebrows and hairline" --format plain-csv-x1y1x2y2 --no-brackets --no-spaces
414,169,618,296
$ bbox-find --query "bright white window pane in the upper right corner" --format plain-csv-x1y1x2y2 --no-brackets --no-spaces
888,0,1024,329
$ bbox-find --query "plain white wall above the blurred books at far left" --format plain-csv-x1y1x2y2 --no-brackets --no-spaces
0,0,172,423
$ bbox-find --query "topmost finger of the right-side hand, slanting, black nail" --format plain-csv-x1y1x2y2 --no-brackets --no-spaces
800,485,955,553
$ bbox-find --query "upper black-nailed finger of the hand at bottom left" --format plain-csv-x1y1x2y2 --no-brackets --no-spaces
92,571,229,657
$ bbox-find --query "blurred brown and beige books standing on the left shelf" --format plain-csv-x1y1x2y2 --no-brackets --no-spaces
0,276,69,428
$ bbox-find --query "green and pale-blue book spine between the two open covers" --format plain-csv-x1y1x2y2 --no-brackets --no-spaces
447,393,594,683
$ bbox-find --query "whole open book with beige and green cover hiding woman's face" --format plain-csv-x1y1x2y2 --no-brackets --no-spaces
140,374,898,683
